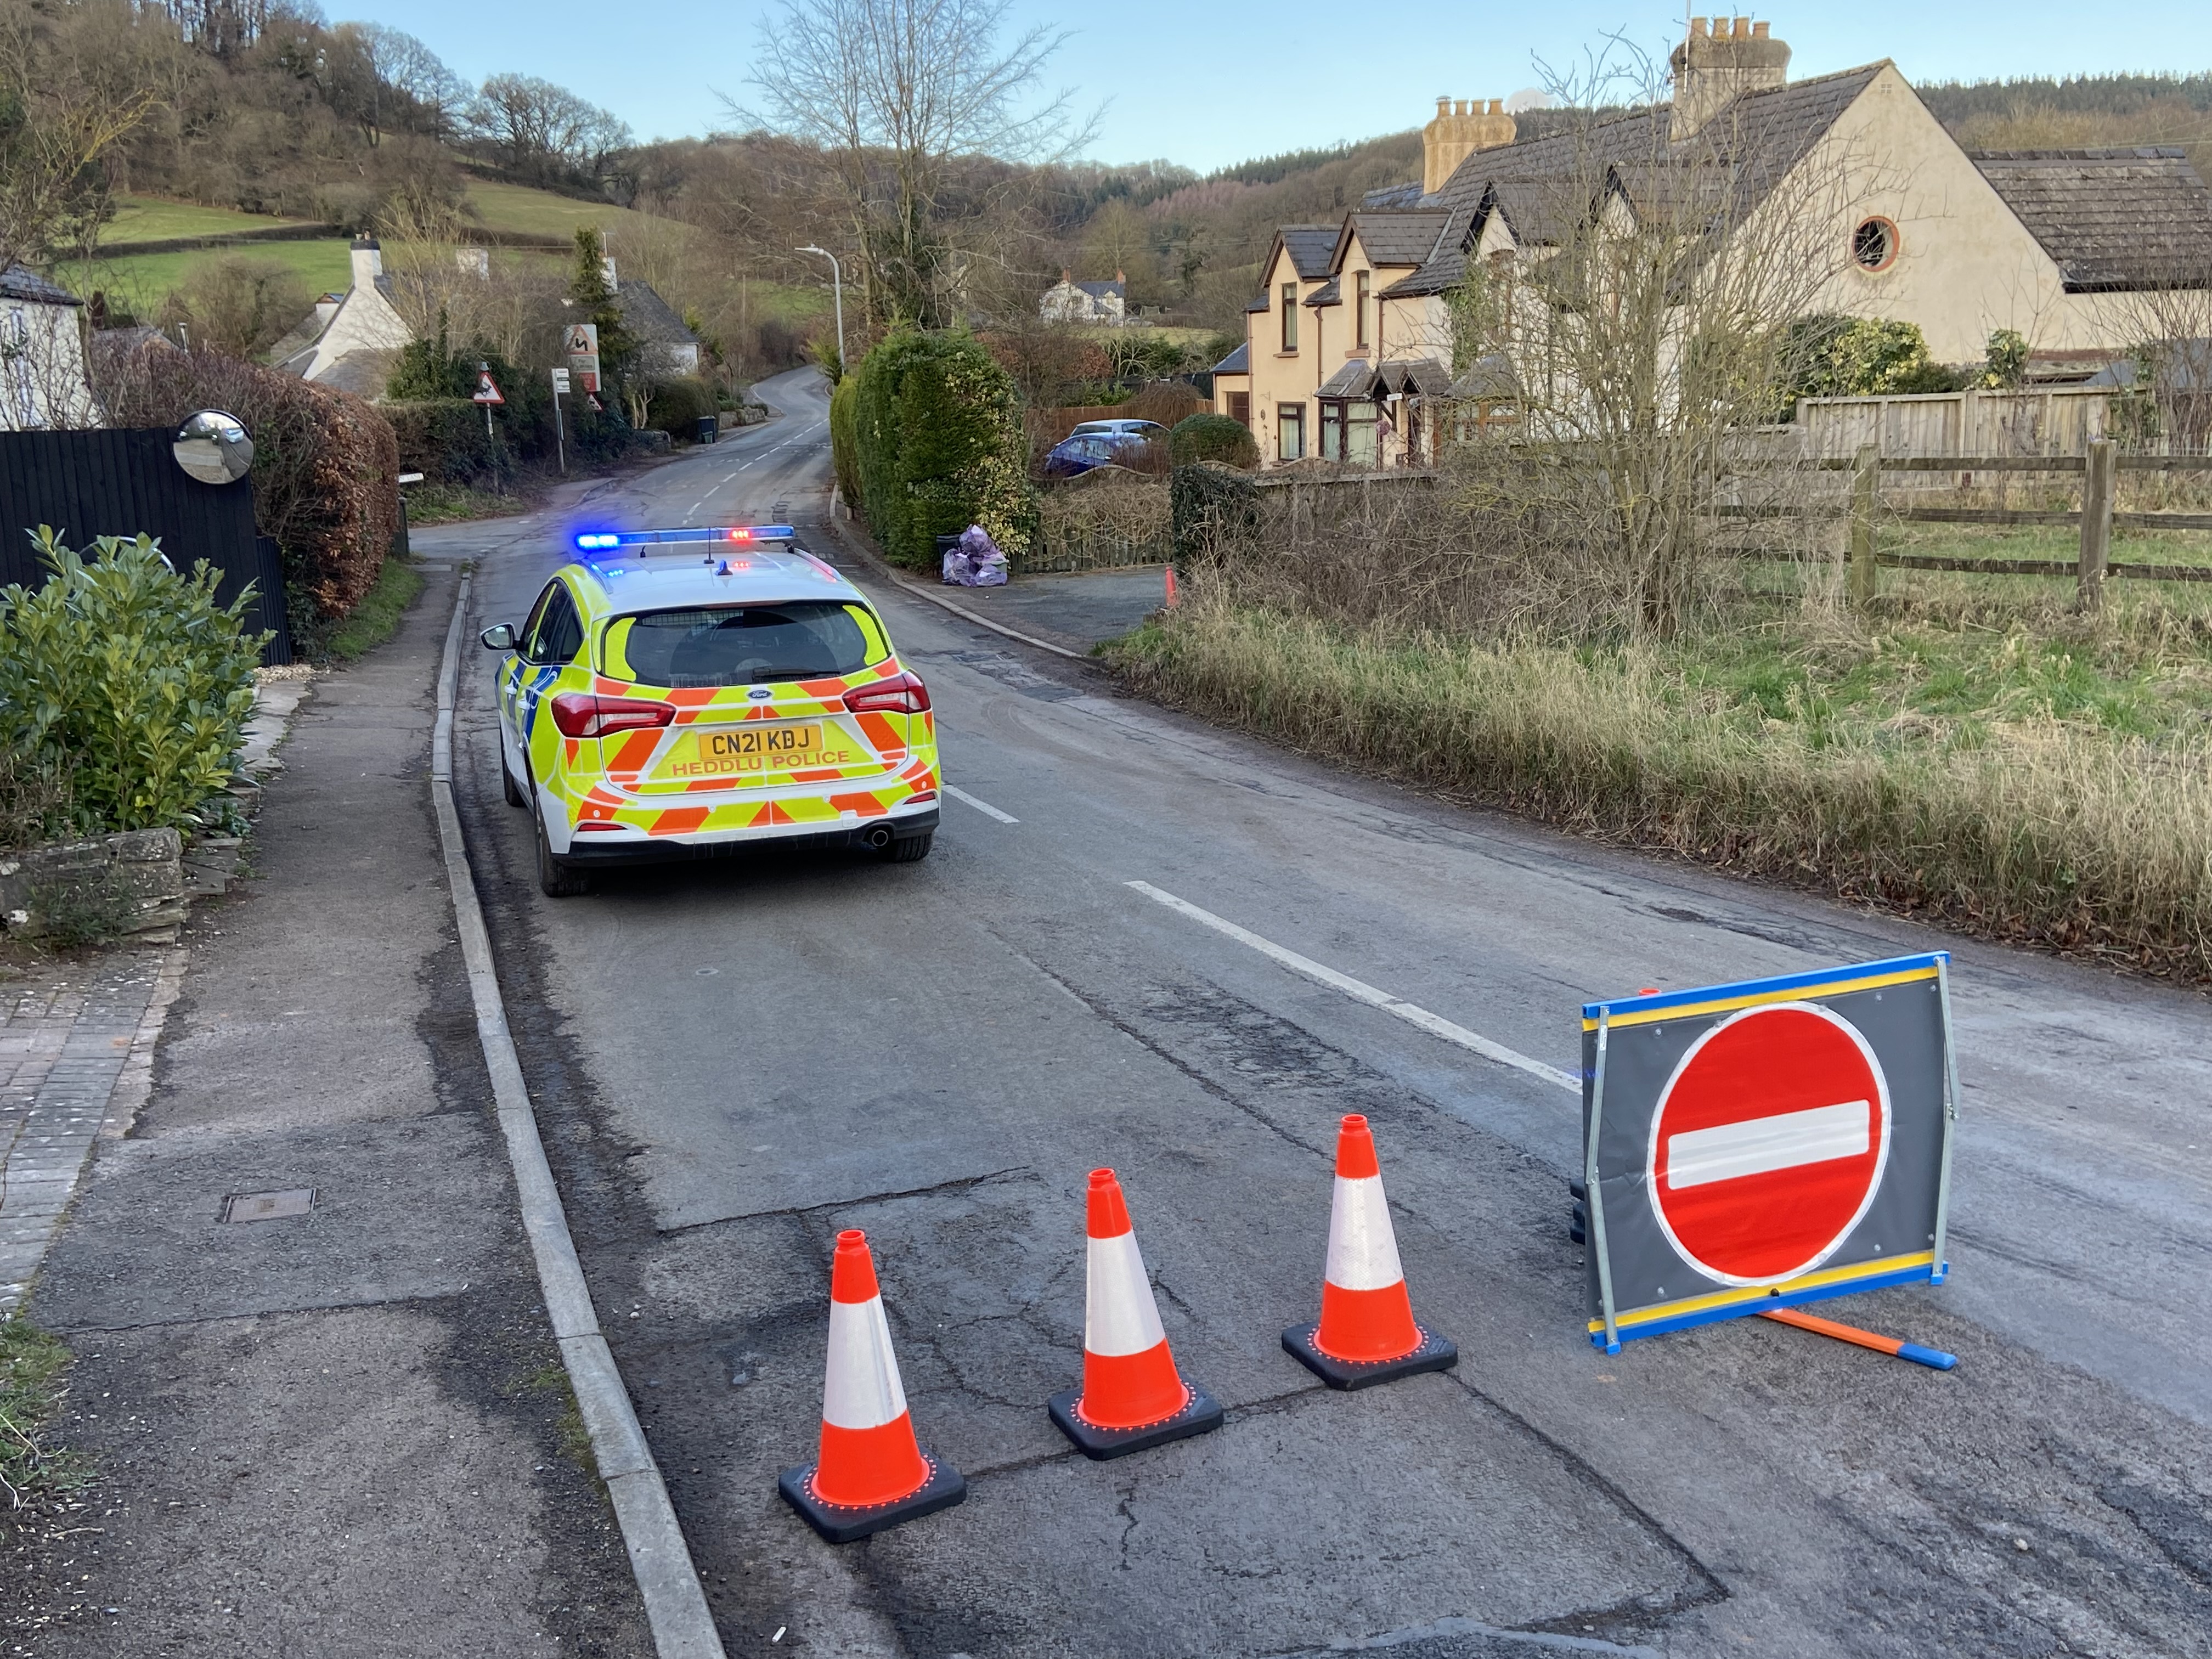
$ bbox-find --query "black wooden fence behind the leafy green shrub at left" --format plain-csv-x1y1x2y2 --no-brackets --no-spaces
0,427,292,664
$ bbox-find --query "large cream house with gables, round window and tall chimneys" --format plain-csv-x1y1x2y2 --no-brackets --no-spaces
1245,18,2212,465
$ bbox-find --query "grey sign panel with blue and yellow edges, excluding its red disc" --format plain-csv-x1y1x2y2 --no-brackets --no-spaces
1582,951,1957,1354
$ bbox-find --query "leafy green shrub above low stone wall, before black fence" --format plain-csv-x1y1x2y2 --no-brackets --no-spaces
0,527,268,830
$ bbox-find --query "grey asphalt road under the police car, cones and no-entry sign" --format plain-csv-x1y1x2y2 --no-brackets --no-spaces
418,376,2212,1659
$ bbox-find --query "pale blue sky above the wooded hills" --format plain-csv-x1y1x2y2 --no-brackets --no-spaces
345,0,2212,170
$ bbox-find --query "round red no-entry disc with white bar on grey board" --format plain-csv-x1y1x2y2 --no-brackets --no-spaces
1644,1002,1889,1285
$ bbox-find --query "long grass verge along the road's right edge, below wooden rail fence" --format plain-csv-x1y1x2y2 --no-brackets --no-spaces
1106,595,2212,982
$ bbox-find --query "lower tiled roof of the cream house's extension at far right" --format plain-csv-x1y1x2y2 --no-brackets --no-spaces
1971,148,2212,294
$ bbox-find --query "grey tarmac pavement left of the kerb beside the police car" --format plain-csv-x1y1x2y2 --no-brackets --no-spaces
0,555,650,1659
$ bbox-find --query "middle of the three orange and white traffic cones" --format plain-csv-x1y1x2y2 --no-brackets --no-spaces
1044,1170,1221,1458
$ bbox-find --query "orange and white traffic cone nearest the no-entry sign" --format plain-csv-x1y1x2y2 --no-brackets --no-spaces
1283,1113,1460,1389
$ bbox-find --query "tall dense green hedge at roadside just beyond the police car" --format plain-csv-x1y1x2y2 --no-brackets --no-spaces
854,330,1037,566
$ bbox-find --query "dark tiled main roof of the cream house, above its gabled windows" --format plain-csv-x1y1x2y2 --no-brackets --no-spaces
1387,62,1887,298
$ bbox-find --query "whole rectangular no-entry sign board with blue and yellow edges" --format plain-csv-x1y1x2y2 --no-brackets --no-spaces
1584,953,1955,1352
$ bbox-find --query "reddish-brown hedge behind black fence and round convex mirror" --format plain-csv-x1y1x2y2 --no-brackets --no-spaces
99,349,400,633
